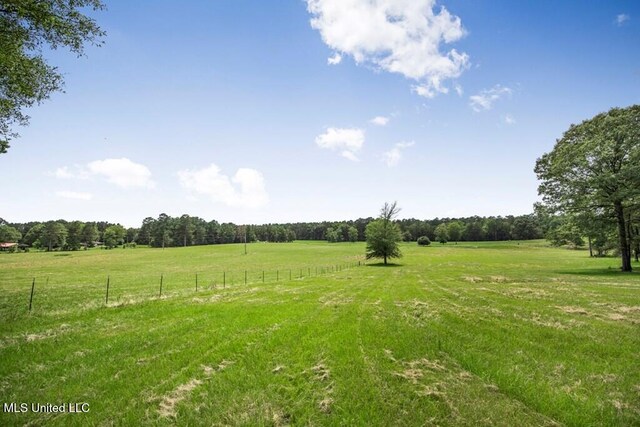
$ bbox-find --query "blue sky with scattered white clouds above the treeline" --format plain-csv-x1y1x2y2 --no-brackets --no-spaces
0,0,640,227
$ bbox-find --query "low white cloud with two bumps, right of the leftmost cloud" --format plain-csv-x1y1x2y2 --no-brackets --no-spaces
178,163,269,208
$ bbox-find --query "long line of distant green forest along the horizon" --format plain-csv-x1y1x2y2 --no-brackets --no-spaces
0,214,550,250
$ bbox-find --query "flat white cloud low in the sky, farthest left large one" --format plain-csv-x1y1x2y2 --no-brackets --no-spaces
87,157,155,188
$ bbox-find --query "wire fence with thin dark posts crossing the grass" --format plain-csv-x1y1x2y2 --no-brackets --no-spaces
0,261,365,318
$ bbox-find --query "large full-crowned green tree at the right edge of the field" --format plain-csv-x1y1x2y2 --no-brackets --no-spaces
535,105,640,271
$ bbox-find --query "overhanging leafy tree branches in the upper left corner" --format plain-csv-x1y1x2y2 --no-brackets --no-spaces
0,0,105,153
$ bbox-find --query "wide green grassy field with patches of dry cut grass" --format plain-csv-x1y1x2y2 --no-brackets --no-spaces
0,242,640,426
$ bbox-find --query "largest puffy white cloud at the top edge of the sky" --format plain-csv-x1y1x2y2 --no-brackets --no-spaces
307,0,469,98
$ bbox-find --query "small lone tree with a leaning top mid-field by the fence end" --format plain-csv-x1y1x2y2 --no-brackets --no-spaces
365,202,402,265
